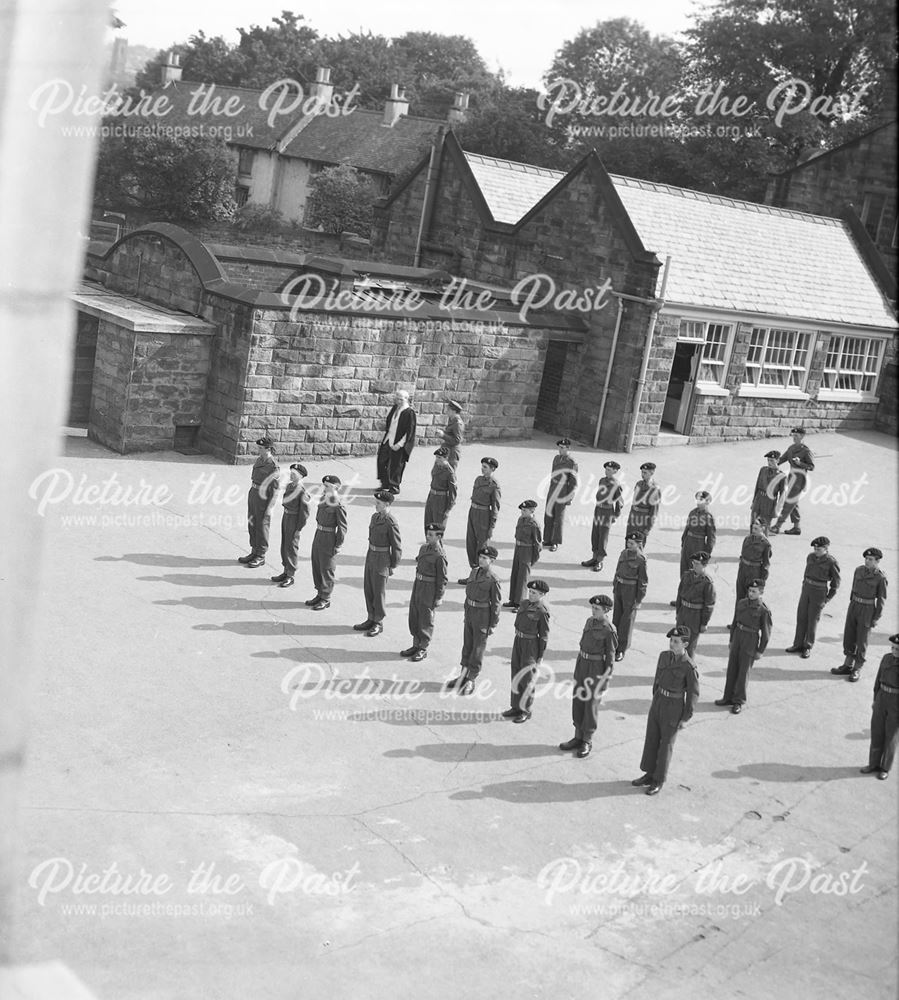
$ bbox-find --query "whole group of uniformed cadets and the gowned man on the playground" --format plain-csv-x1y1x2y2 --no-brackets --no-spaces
238,412,899,795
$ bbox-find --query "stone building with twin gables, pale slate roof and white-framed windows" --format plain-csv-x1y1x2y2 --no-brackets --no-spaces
372,133,896,450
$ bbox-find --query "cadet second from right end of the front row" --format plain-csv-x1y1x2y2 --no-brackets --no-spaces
559,594,618,757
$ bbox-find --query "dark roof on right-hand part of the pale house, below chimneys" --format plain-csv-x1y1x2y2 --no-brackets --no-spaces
283,108,446,174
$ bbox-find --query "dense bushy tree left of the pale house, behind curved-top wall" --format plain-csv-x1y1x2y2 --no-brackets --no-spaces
94,133,237,220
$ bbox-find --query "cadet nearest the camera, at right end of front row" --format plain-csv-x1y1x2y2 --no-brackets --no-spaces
631,625,699,795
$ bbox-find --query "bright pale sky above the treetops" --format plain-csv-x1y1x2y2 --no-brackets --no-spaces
112,0,700,89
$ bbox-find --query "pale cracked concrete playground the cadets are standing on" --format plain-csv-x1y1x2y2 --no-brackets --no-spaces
8,432,899,1000
